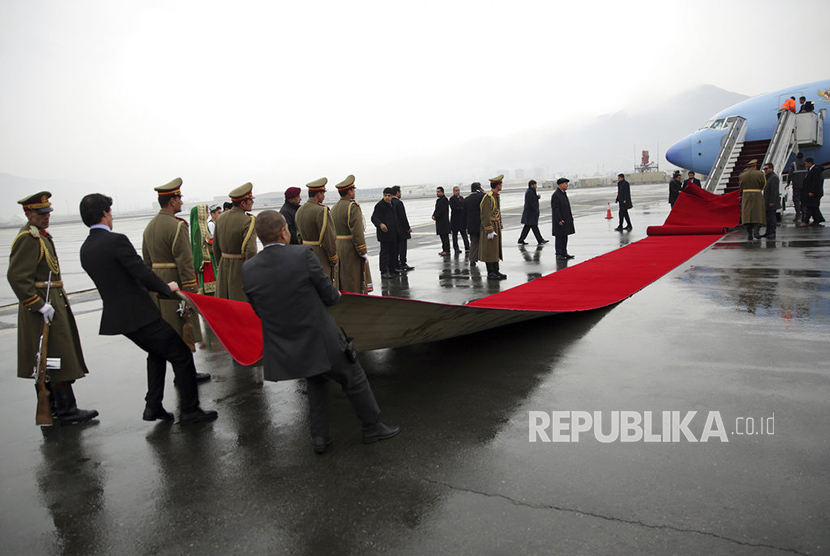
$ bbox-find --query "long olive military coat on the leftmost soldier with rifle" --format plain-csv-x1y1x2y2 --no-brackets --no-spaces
6,225,89,382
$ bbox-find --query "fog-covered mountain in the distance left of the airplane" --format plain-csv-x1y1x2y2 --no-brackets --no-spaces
364,85,749,184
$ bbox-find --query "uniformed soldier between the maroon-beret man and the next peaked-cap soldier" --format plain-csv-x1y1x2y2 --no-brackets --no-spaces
296,178,337,287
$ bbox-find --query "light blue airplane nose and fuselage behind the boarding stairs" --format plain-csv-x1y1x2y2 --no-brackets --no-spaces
666,79,830,181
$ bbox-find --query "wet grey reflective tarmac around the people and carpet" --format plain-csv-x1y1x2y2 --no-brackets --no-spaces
0,186,830,555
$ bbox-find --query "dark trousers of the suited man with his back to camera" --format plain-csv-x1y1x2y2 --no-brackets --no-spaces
306,354,380,438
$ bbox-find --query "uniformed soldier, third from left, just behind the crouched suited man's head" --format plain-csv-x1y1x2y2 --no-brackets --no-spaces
213,182,256,301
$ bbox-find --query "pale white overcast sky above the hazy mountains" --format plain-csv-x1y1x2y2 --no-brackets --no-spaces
0,0,830,212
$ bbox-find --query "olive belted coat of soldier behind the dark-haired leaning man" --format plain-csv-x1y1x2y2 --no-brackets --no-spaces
141,209,202,342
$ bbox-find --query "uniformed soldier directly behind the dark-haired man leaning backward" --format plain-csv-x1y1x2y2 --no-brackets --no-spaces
141,178,210,382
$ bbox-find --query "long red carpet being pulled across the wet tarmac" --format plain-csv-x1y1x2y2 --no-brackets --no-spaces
185,186,740,365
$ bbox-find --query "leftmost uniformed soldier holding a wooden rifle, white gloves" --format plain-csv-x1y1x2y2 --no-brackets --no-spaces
7,191,98,425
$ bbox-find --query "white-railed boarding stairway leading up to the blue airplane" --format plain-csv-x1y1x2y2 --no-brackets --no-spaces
704,110,827,194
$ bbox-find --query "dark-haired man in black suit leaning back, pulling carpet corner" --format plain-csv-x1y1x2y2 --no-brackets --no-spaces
80,193,217,425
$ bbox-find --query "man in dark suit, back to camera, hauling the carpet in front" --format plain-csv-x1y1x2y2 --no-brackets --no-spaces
242,211,400,454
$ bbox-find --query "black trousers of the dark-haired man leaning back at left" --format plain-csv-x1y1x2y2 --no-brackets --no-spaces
124,317,199,411
